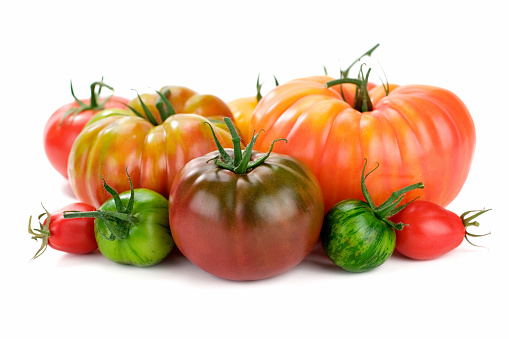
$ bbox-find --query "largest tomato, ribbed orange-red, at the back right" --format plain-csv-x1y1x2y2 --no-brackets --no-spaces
251,76,475,210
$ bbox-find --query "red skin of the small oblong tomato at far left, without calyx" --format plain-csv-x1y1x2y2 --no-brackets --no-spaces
43,202,97,254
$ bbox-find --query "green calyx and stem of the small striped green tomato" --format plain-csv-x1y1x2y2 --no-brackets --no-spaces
361,158,424,231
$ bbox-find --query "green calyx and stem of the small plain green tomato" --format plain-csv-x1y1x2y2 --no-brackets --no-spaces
64,168,137,241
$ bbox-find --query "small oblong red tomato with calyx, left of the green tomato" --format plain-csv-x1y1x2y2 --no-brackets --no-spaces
28,202,97,259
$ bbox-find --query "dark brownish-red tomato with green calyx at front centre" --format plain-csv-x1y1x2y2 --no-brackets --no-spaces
169,118,324,280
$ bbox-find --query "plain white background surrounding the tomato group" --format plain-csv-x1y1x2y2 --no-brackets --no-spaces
0,0,509,338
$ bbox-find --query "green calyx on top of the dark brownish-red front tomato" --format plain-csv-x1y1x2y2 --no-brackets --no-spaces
205,117,288,174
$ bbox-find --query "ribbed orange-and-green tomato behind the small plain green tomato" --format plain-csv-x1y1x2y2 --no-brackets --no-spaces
68,87,236,207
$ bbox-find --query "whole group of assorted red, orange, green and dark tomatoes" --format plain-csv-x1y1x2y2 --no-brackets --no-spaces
30,47,485,280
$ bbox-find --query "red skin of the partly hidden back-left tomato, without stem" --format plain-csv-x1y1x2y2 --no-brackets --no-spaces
43,96,129,178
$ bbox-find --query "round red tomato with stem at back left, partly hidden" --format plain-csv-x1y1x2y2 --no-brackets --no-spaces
43,81,129,178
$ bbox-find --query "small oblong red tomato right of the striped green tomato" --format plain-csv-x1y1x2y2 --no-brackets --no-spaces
391,200,489,260
